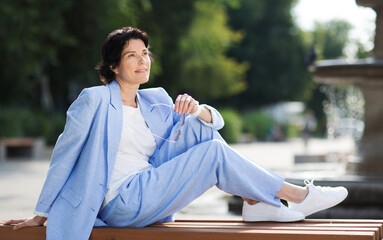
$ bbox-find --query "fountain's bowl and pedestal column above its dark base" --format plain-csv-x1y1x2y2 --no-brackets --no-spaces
314,0,383,177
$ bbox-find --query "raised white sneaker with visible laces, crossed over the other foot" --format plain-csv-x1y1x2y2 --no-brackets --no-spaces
289,180,348,217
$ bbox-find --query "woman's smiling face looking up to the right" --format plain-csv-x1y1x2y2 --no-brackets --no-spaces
113,39,151,85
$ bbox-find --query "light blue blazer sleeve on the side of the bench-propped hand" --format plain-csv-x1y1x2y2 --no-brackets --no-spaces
35,89,95,216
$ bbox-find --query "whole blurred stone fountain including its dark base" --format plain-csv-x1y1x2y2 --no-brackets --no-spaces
292,0,383,219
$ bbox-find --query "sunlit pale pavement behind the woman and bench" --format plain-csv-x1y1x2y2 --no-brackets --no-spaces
0,139,354,222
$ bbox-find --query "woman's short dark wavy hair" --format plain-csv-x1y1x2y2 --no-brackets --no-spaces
95,27,153,84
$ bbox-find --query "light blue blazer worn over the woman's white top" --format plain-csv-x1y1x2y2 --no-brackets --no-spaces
35,81,223,240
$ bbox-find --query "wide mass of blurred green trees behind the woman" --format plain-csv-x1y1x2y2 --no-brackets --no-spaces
0,0,360,142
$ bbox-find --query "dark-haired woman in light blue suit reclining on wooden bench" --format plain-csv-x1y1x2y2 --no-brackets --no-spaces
7,27,347,240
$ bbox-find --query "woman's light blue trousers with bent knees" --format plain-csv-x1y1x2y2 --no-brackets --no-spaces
100,117,284,227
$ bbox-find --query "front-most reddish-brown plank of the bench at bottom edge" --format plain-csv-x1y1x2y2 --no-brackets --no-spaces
90,227,374,240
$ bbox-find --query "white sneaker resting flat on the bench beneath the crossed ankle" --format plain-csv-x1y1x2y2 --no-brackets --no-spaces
242,201,305,222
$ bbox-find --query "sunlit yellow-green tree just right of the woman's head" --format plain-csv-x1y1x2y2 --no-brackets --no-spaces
133,0,246,101
